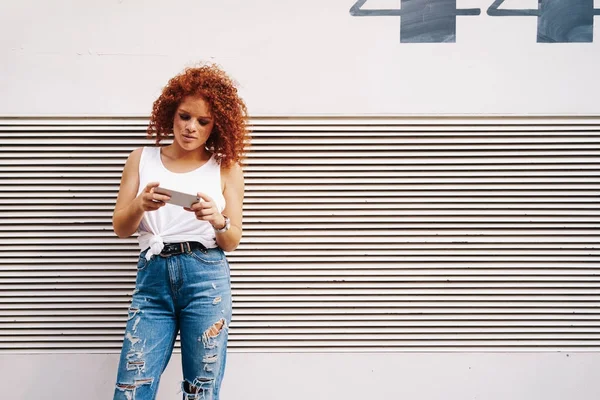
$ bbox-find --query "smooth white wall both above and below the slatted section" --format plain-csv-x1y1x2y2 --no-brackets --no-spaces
0,0,600,400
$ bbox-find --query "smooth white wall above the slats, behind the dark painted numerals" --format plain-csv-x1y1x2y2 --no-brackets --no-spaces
0,0,600,115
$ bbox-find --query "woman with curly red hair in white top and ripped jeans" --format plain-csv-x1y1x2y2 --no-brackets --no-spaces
113,65,248,400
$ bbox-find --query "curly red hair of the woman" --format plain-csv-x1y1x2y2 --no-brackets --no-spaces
147,64,250,167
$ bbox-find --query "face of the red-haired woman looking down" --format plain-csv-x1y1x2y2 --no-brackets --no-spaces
173,96,214,151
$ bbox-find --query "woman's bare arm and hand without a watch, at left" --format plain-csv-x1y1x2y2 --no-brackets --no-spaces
112,149,169,238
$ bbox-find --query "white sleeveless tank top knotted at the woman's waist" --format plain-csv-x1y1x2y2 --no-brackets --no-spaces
138,147,225,260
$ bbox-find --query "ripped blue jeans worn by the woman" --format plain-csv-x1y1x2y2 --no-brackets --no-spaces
114,248,231,400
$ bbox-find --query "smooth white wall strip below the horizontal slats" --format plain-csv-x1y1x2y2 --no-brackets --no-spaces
0,353,600,400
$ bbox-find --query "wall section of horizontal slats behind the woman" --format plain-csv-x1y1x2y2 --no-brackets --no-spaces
0,117,600,352
